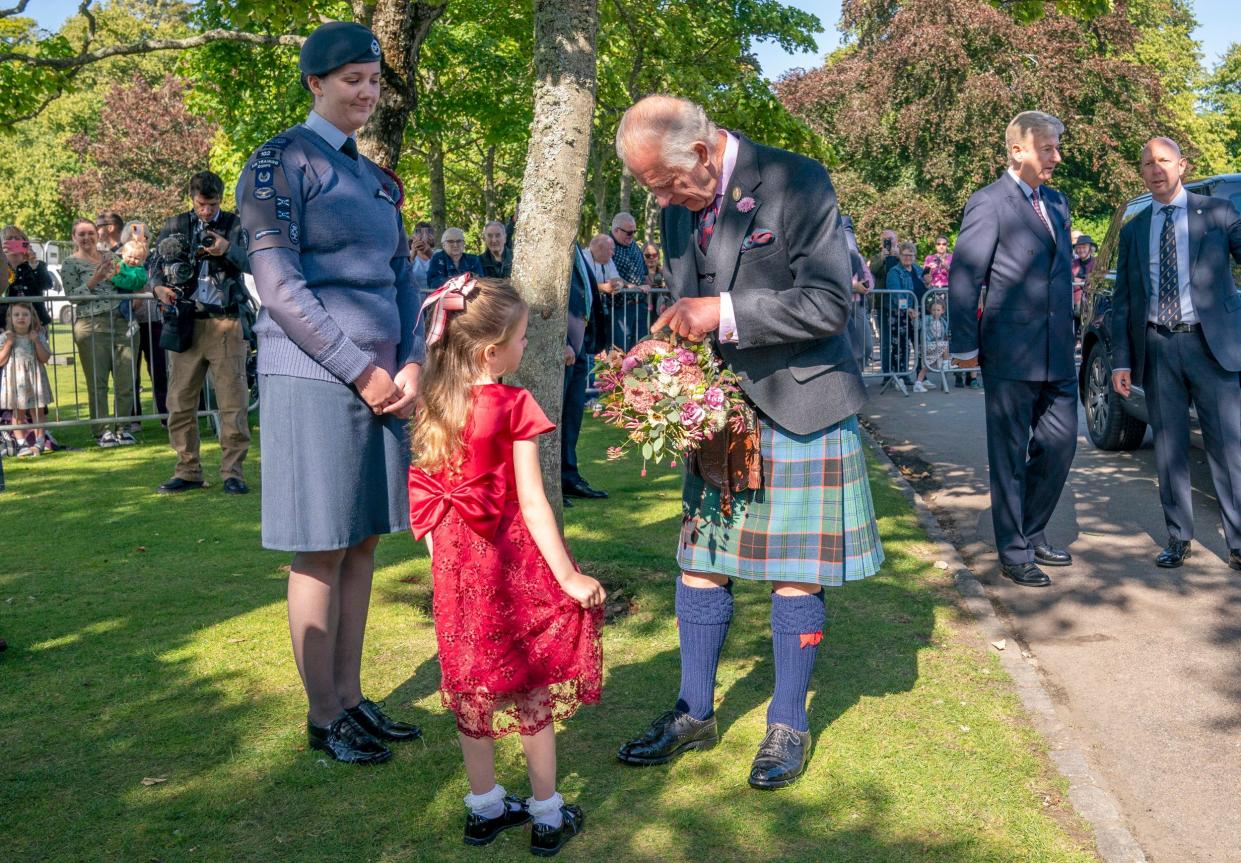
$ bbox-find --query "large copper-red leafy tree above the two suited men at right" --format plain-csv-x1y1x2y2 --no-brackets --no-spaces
777,0,1171,249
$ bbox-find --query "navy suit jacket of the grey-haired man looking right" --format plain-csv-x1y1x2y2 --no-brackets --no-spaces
948,171,1077,381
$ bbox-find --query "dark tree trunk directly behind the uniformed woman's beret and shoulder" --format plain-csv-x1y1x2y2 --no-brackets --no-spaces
354,0,446,169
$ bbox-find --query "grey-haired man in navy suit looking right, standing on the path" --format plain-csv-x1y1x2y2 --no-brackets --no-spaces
948,111,1077,587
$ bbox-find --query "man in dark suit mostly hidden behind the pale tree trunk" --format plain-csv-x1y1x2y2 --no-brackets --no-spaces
560,243,608,507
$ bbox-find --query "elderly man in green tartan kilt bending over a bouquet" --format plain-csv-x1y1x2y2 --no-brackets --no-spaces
617,96,884,788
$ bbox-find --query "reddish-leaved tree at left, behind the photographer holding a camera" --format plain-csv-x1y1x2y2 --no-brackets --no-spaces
61,76,216,225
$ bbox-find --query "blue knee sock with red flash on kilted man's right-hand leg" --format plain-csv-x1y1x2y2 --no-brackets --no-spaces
767,590,827,731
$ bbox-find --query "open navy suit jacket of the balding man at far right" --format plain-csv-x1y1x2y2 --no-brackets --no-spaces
1112,192,1241,386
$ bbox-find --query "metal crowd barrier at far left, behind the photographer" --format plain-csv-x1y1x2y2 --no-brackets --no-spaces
0,293,235,444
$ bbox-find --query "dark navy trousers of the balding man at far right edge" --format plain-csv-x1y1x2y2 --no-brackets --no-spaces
1142,325,1241,549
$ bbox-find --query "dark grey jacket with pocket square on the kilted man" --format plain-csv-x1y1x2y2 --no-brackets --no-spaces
661,135,866,435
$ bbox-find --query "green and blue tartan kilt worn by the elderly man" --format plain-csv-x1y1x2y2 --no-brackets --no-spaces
676,415,884,587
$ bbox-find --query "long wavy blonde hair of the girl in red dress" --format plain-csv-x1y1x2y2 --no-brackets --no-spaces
411,278,526,473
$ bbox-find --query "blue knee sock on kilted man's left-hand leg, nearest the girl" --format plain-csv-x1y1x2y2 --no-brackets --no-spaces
676,579,732,719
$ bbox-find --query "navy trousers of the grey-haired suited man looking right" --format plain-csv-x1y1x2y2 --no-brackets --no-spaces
983,368,1077,564
